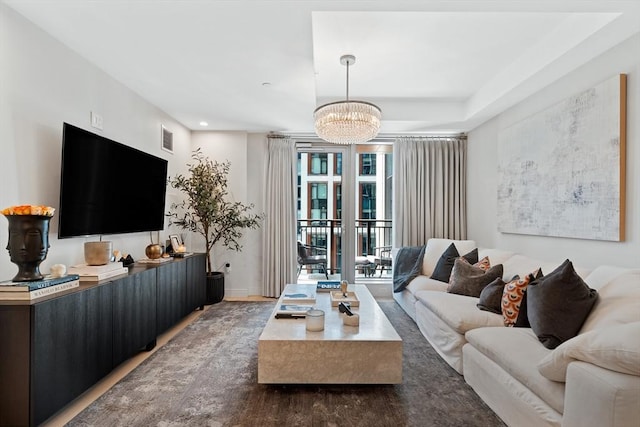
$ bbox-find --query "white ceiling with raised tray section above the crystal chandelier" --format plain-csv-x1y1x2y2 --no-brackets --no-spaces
3,0,640,134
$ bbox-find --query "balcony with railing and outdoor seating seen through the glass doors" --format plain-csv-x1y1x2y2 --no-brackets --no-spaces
297,219,392,283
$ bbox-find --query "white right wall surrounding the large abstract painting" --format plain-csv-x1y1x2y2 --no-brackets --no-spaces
467,35,640,267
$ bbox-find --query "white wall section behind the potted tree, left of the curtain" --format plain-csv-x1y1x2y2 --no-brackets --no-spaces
189,131,266,296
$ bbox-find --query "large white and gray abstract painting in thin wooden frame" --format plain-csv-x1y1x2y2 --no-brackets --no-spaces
497,74,626,241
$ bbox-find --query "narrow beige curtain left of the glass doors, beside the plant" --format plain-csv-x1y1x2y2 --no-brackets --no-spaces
262,137,297,298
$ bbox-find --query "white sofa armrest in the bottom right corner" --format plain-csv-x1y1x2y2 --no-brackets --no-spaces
562,361,640,427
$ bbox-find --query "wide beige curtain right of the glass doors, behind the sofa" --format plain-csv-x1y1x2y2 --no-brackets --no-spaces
393,136,467,247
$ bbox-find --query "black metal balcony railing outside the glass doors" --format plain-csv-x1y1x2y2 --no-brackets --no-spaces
297,219,392,273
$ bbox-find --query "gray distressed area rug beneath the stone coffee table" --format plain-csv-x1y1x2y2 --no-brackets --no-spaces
67,301,504,427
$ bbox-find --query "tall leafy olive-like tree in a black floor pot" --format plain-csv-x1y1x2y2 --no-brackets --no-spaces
167,149,262,304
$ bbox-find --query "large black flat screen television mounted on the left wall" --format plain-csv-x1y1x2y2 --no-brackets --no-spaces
58,123,167,238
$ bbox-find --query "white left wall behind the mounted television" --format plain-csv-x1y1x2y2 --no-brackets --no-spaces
0,3,191,280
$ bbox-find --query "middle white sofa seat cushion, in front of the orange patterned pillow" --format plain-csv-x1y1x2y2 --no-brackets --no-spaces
415,291,502,334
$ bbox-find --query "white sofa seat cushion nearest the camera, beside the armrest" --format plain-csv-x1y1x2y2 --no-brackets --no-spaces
465,328,564,413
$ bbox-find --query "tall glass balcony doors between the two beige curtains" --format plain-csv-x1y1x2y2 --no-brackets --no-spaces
297,143,392,283
